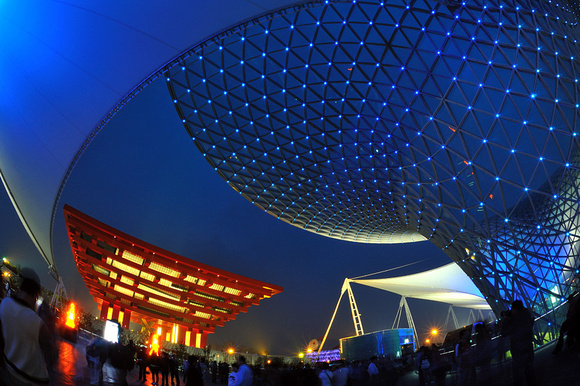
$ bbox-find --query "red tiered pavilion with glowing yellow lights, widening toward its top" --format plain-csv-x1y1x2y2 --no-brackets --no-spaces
64,205,282,348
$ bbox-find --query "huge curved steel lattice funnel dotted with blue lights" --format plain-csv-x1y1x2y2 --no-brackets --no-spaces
166,0,580,340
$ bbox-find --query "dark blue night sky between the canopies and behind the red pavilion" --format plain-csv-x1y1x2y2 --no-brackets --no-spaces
0,79,468,355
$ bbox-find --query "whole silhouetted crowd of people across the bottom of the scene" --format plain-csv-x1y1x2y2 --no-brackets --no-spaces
0,268,580,386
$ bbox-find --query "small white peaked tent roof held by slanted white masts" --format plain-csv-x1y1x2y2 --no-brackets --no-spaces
350,263,490,309
